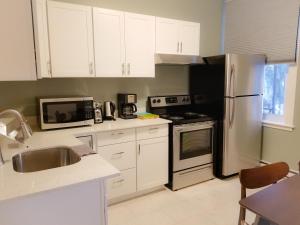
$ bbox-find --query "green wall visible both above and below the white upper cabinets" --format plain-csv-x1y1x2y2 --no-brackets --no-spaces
0,0,223,116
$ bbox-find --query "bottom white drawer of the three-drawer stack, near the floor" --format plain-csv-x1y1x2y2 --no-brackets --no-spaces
106,168,136,199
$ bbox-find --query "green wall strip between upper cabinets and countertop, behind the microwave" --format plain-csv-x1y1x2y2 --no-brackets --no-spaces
0,65,189,116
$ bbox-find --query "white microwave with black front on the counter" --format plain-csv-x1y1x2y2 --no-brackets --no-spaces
38,97,94,130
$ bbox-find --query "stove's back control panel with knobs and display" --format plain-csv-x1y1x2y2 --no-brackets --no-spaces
149,95,191,108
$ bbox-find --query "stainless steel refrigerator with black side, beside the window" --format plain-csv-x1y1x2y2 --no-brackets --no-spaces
190,54,265,177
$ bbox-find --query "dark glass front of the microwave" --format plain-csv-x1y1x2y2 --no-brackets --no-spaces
43,101,93,123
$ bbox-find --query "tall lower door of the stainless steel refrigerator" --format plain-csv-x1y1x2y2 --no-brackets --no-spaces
222,95,262,176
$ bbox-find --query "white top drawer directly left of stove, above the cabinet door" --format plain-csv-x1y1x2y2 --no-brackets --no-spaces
136,124,169,140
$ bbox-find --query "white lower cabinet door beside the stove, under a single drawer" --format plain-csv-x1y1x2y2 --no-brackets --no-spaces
137,137,168,191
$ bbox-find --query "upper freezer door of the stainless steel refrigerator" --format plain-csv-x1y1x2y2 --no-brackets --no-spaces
225,54,265,97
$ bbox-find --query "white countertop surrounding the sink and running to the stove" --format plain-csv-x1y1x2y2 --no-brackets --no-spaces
0,118,171,201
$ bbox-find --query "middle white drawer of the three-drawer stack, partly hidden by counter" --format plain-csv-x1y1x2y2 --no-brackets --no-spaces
98,142,136,170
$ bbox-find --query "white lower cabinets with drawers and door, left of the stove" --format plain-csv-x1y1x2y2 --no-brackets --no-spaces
95,124,169,200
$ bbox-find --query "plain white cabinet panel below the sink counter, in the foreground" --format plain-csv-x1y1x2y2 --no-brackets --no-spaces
0,179,108,225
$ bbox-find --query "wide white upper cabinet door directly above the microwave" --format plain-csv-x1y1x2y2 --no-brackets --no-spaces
48,1,95,77
